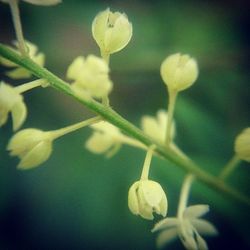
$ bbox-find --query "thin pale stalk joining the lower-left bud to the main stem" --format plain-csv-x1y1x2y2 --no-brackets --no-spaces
49,116,103,140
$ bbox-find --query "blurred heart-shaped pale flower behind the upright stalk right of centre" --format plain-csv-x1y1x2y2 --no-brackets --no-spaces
141,110,175,144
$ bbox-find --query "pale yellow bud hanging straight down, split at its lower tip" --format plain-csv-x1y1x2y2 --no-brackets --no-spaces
128,180,168,220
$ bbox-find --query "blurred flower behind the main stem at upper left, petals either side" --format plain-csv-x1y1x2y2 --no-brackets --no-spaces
0,41,45,79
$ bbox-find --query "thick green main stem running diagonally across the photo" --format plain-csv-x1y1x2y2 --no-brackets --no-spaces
0,44,250,206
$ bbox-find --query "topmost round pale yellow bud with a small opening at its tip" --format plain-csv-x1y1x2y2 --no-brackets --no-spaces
92,8,132,55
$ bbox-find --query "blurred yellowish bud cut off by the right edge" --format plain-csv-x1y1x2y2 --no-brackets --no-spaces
234,128,250,162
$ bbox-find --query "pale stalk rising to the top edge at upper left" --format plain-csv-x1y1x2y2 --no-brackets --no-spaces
9,0,28,56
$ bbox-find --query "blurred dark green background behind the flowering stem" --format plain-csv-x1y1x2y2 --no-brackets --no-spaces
0,0,250,250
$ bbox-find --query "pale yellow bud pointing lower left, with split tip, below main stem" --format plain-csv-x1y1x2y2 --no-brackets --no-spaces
7,128,52,170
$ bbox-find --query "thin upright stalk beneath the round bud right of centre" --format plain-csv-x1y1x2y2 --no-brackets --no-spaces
165,90,178,147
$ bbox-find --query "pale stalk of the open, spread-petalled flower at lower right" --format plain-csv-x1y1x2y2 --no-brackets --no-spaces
177,174,194,218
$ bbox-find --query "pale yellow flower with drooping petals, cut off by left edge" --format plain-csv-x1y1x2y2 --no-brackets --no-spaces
0,82,27,130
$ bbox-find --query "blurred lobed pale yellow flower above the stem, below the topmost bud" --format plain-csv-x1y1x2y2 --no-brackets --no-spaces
67,55,113,98
